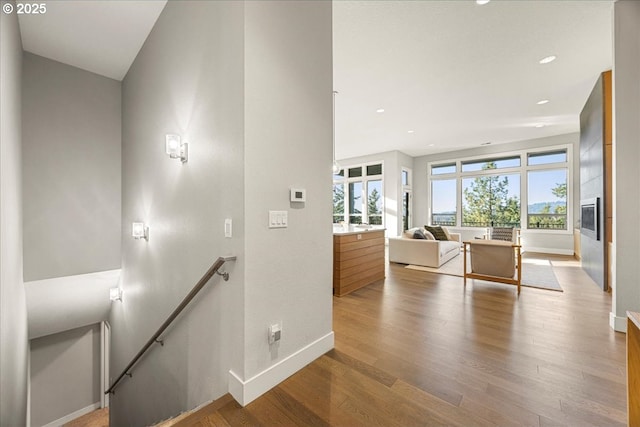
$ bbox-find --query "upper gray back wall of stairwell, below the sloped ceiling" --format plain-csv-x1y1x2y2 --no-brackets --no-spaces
22,53,121,281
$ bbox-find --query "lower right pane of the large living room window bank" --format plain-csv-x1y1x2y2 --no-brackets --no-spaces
527,169,567,230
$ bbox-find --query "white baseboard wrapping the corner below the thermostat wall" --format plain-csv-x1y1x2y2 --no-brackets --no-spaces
229,331,334,406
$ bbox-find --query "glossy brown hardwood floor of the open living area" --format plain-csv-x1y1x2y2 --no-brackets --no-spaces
162,257,627,427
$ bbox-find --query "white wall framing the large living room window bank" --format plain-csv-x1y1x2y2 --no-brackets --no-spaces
413,133,580,255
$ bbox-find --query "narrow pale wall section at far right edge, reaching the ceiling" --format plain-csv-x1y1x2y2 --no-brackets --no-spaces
611,0,640,331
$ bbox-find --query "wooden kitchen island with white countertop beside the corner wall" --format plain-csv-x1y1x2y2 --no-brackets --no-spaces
333,228,384,297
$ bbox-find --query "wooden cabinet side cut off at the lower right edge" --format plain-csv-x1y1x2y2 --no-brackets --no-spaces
627,311,640,426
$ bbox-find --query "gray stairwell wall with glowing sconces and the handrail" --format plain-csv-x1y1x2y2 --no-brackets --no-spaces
110,1,245,427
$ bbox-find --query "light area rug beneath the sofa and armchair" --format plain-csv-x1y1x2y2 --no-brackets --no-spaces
405,254,562,292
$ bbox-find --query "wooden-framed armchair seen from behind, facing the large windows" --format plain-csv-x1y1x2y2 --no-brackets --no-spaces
463,240,522,295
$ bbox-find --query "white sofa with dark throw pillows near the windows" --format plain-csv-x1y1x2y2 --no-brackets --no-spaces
389,227,462,268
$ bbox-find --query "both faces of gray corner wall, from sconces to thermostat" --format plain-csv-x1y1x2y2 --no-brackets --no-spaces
111,1,332,426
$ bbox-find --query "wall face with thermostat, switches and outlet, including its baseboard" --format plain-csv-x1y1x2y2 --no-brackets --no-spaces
235,1,333,404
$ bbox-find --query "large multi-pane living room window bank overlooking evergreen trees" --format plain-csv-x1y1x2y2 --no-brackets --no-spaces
429,146,571,230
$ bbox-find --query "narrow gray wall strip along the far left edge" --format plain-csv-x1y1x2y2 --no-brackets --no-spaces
0,2,29,426
